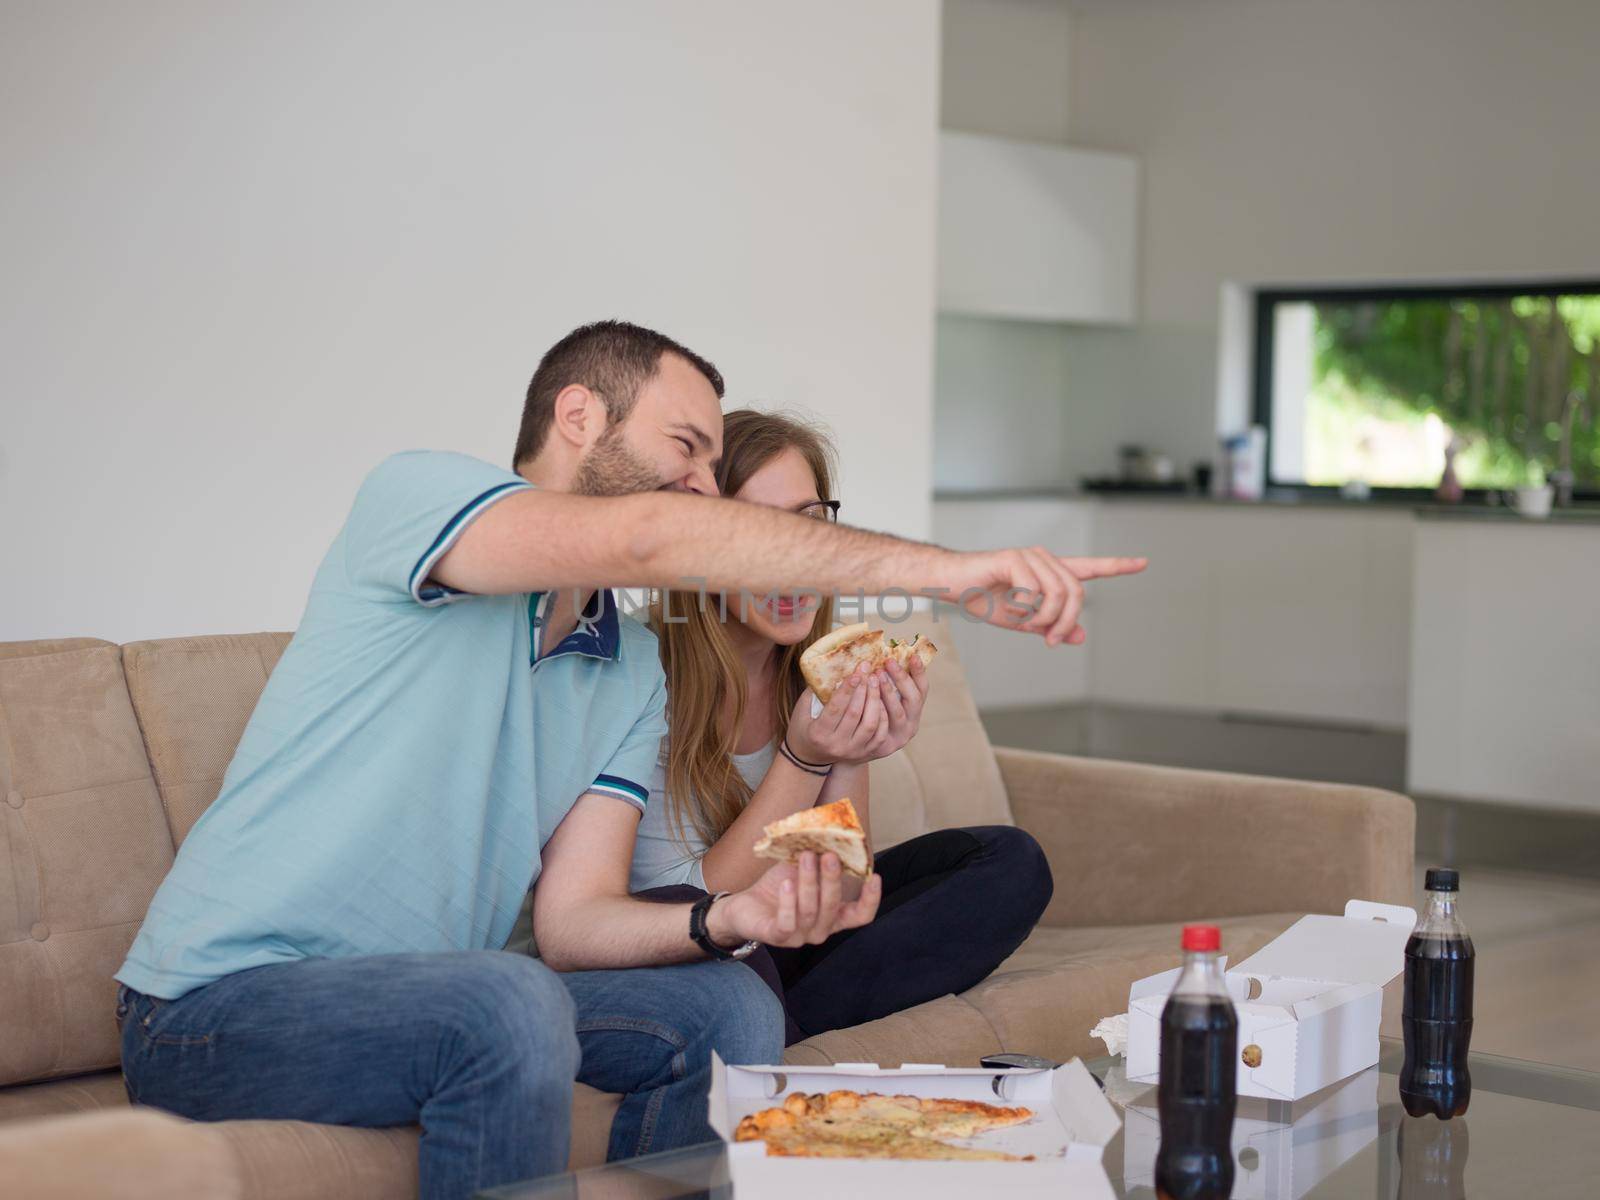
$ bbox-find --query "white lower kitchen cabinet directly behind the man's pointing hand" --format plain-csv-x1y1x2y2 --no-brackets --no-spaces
933,498,1096,709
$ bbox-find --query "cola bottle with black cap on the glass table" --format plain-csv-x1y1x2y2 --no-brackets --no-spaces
1400,867,1474,1122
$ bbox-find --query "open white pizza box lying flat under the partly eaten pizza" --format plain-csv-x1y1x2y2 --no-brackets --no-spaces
710,1054,1122,1200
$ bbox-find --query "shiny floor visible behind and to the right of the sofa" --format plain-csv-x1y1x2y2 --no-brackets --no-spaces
984,707,1600,1070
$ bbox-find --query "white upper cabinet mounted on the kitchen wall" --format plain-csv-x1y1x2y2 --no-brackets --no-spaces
939,133,1139,323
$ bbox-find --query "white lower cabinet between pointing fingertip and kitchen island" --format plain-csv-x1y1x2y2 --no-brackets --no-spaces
1083,501,1411,728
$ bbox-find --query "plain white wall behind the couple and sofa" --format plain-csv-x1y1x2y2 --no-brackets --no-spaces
0,0,939,640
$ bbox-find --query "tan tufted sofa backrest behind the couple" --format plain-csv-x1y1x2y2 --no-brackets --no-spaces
0,614,1011,1086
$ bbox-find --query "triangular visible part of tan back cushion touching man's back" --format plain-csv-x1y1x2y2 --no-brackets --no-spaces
122,634,291,846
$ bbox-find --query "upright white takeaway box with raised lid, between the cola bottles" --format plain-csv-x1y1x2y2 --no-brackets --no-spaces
1128,899,1416,1101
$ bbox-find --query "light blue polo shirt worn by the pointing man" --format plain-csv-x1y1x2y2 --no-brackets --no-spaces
118,451,666,1000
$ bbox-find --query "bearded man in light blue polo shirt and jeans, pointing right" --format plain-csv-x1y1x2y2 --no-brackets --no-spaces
117,322,1145,1200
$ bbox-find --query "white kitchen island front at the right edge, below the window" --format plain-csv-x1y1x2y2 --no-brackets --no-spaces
1406,520,1600,811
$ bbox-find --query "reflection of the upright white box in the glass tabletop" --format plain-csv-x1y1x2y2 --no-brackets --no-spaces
1122,1067,1378,1200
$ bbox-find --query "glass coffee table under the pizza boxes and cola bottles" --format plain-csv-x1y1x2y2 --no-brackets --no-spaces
480,1038,1600,1200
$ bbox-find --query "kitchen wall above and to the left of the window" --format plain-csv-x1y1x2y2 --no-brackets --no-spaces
1069,0,1600,480
